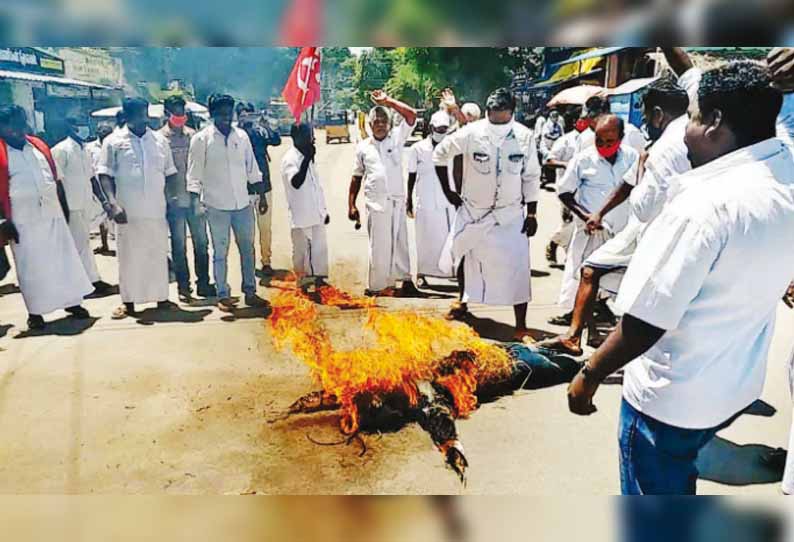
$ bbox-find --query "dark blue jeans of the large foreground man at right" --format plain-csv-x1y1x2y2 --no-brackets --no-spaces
618,399,722,495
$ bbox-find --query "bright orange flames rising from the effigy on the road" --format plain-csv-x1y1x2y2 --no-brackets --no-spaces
269,287,512,434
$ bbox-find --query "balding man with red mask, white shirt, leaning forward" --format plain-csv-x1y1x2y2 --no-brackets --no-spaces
550,115,639,325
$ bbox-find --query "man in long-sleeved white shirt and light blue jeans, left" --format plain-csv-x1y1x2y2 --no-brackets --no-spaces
187,94,267,312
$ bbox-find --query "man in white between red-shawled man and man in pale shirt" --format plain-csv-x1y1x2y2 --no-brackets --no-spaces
52,117,111,295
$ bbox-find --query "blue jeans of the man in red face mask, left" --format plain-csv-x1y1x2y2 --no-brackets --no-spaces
166,205,210,292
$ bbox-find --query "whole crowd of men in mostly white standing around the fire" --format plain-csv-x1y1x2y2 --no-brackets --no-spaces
0,48,794,494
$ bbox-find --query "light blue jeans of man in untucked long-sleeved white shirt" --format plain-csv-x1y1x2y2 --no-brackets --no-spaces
207,205,256,299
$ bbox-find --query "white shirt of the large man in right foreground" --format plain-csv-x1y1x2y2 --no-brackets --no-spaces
617,138,794,429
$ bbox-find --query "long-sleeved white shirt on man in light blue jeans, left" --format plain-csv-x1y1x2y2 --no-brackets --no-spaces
187,124,262,211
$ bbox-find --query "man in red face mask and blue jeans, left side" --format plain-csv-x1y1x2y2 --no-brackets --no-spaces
160,96,217,302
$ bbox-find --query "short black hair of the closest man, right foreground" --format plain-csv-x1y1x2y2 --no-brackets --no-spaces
698,60,783,147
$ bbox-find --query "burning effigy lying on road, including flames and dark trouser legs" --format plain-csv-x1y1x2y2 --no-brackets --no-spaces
269,285,579,482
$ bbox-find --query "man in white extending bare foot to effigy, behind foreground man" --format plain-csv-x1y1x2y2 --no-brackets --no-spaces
540,78,692,356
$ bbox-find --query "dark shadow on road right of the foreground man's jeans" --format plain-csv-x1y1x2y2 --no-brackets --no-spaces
697,437,783,486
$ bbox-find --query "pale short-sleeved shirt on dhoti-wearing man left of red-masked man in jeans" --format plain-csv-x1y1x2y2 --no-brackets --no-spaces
97,126,176,219
